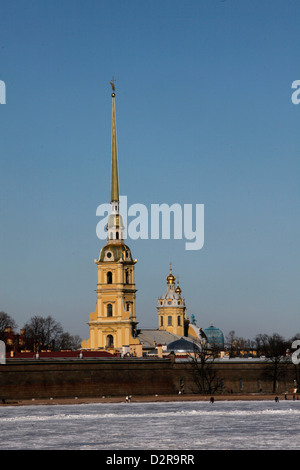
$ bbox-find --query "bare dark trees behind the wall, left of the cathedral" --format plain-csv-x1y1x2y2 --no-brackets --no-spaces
0,311,81,352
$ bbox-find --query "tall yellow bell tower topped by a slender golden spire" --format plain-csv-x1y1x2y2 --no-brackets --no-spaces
82,79,140,349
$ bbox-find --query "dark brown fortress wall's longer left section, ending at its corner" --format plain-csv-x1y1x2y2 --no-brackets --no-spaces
0,358,174,399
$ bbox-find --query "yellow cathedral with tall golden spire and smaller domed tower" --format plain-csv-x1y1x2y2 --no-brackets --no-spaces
82,81,218,357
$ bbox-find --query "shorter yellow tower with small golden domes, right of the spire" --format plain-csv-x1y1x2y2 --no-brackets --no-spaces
157,268,188,336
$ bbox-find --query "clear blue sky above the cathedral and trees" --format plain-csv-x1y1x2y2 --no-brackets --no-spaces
0,0,300,339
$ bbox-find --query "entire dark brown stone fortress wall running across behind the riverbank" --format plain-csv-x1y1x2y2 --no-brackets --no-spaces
0,358,295,399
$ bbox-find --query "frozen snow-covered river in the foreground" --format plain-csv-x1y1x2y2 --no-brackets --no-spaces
0,400,300,450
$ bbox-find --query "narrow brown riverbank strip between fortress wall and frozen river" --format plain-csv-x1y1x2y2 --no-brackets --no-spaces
0,393,299,406
